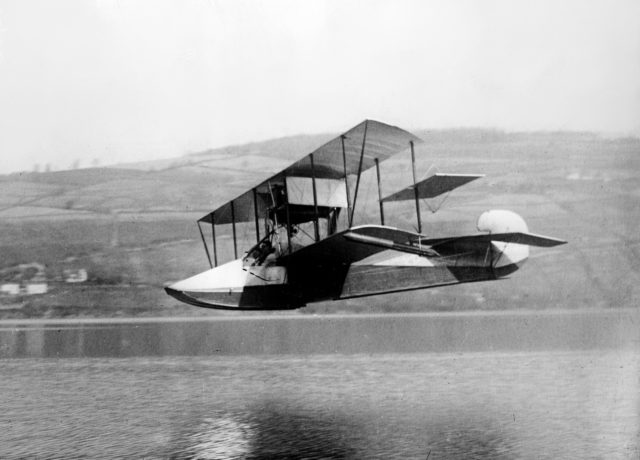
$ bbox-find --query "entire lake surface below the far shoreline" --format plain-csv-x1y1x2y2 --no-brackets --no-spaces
0,309,640,459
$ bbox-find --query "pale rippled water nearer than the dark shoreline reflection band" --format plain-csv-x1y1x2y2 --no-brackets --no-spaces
0,315,640,459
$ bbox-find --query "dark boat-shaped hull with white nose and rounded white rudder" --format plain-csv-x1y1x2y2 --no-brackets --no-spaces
166,211,529,310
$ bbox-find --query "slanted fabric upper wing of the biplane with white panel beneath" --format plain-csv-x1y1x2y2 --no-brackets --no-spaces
199,120,422,224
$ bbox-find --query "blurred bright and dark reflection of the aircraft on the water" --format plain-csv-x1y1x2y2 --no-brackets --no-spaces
170,399,517,459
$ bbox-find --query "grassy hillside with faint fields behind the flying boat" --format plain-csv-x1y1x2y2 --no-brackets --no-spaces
0,130,640,316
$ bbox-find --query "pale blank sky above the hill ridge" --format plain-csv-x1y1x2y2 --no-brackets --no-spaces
0,0,640,173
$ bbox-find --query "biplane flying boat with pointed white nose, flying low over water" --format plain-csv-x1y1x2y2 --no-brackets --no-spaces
165,120,565,310
